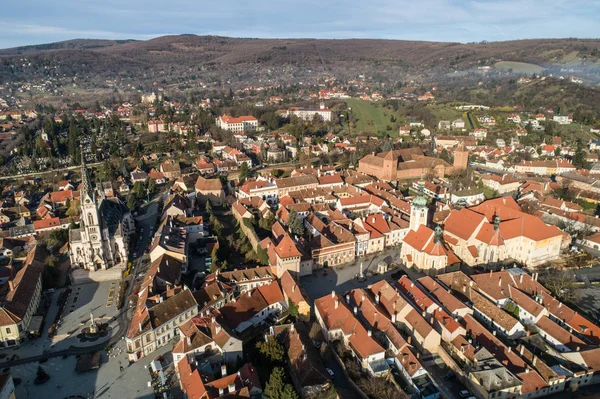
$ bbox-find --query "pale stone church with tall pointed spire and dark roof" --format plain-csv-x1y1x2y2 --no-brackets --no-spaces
69,154,135,271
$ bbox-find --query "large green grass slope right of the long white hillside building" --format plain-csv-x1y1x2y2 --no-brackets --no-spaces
345,98,398,136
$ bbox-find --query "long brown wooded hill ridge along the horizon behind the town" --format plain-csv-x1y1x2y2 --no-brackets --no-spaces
0,35,600,85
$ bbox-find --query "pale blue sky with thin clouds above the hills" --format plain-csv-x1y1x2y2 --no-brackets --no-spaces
0,0,600,48
